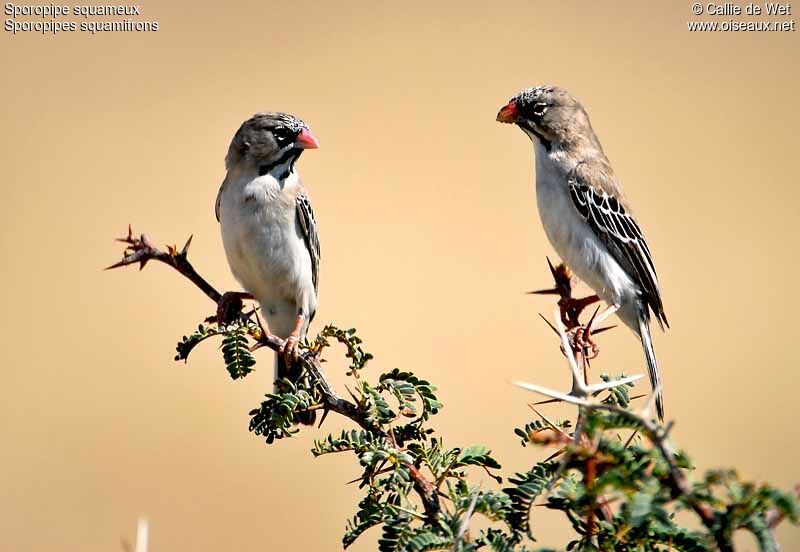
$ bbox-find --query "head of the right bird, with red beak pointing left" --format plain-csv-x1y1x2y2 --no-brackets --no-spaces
497,86,593,147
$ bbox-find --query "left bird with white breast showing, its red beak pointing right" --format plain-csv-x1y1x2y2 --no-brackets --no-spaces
215,112,320,424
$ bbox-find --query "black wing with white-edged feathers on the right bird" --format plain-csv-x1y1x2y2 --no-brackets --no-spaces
568,163,669,328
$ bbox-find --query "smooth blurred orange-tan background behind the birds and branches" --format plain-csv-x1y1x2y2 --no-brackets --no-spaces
0,0,800,552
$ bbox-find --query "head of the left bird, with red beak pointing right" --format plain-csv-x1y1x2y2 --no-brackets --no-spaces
225,112,319,179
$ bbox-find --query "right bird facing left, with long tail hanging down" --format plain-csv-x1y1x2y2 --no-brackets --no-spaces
497,86,669,420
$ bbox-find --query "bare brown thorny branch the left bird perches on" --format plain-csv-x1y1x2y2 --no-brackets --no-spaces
106,225,441,520
